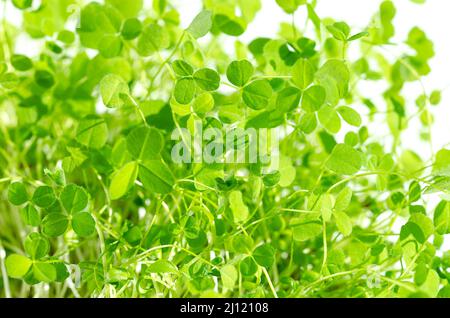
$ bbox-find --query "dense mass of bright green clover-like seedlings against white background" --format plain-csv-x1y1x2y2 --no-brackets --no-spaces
0,0,450,297
